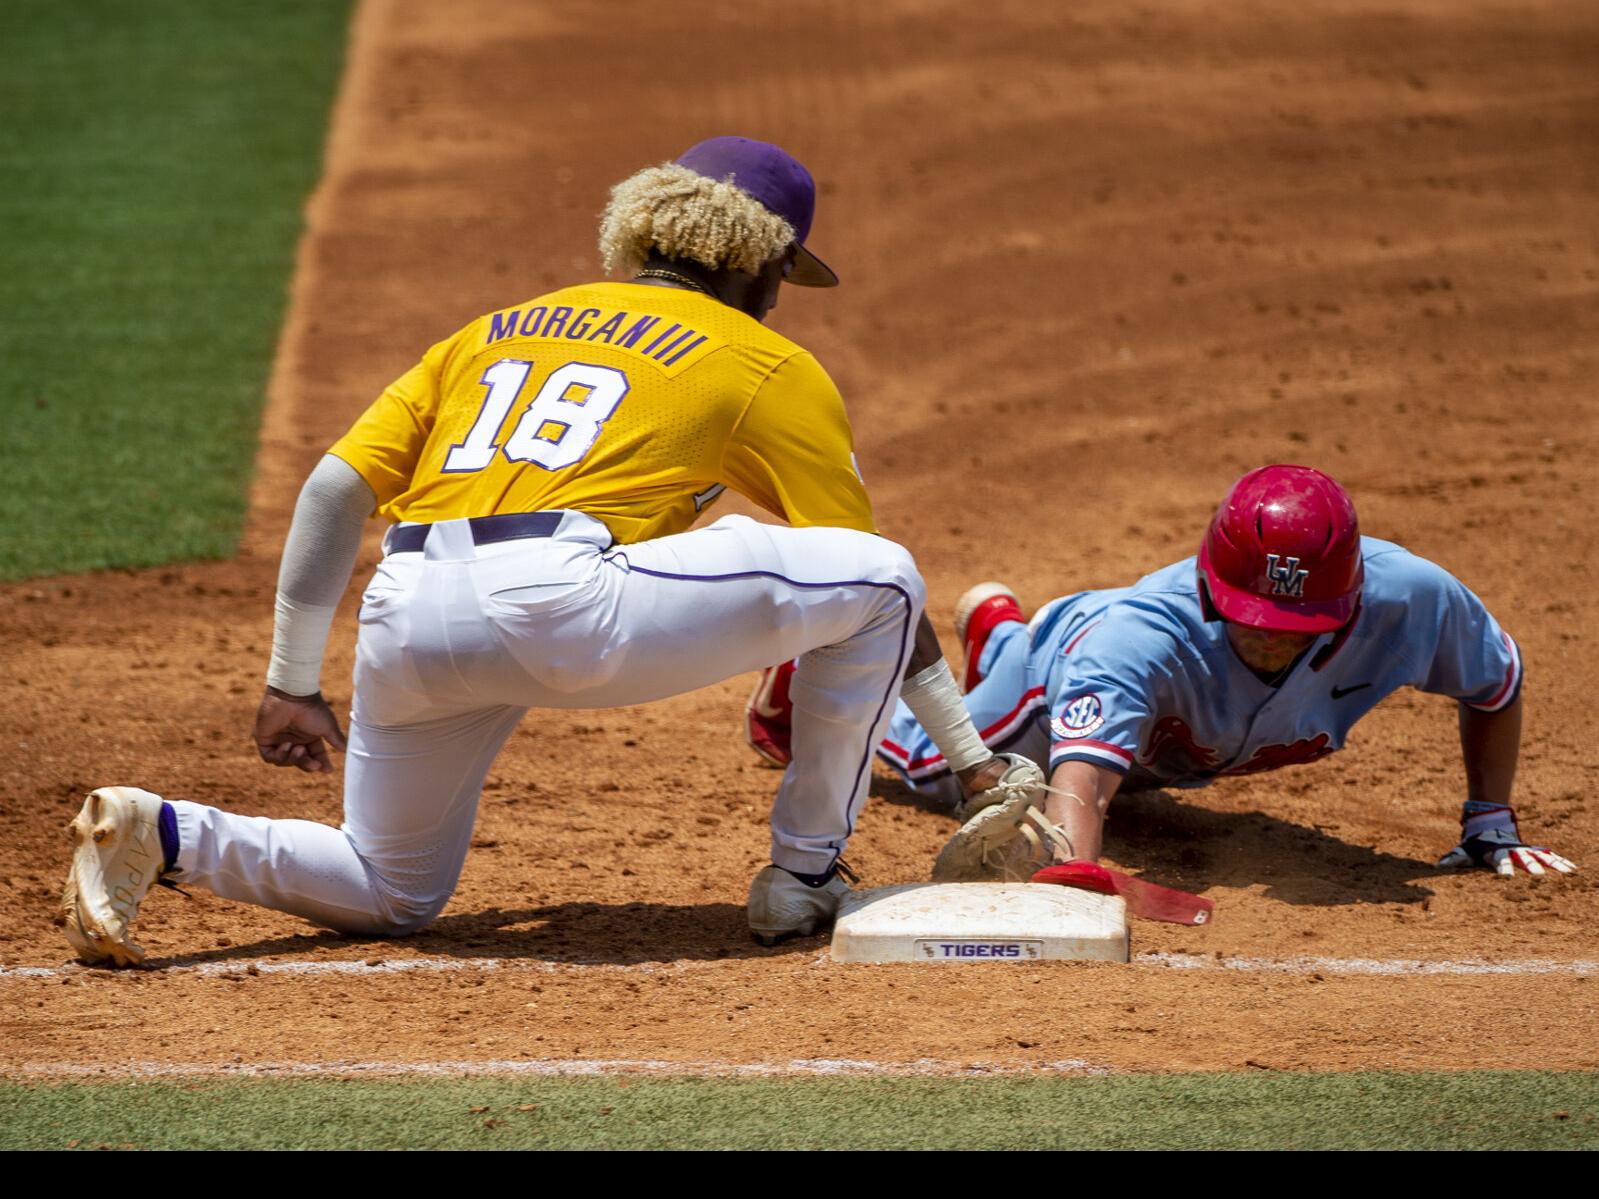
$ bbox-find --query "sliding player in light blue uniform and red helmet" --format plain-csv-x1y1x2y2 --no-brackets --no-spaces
750,465,1575,879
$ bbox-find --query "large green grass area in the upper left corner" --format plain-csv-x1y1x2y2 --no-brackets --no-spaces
0,0,349,579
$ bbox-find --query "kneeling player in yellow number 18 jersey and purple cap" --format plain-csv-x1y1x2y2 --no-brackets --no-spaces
62,137,1043,962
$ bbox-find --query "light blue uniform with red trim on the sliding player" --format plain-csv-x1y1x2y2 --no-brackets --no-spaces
881,537,1521,788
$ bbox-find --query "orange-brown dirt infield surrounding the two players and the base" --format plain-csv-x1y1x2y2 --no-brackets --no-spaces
9,0,1599,1073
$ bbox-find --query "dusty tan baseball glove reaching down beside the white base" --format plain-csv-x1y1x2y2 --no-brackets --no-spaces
932,753,1071,882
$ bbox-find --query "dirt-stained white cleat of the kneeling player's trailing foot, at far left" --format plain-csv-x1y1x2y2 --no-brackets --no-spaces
56,787,166,966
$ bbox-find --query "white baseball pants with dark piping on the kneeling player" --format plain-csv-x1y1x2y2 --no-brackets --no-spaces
173,512,926,934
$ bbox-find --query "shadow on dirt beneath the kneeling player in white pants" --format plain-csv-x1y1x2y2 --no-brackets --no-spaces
137,903,828,969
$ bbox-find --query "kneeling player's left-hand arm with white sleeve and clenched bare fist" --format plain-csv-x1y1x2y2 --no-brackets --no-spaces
254,454,377,772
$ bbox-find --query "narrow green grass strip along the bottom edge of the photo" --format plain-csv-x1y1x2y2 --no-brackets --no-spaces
0,1073,1599,1149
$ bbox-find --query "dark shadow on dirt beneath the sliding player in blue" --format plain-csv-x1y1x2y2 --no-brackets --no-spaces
871,775,1442,906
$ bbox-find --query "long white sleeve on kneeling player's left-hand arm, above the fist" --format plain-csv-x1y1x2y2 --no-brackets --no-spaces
267,454,377,695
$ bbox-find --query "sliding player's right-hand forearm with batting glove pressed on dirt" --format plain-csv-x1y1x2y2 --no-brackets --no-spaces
1438,695,1577,876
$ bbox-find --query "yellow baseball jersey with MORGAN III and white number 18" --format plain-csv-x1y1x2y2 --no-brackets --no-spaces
329,283,876,544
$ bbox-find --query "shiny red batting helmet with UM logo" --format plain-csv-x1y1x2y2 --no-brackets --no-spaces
1199,467,1366,633
